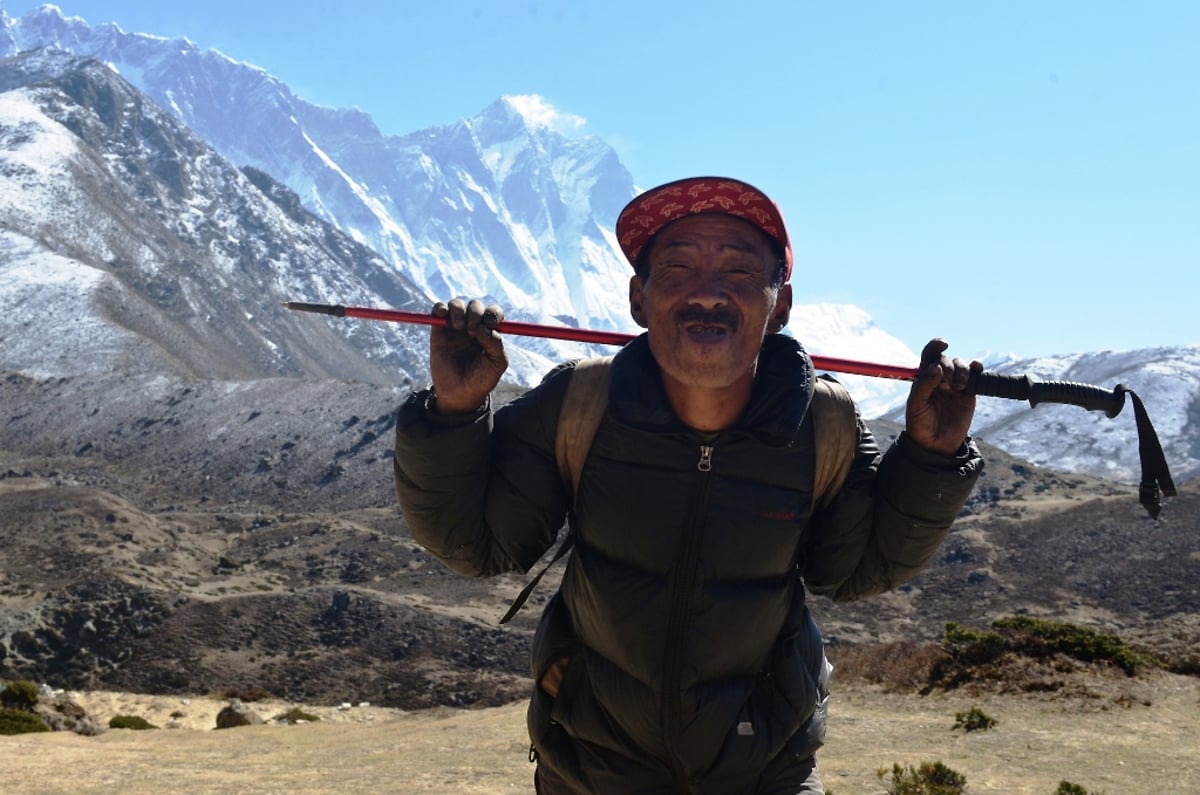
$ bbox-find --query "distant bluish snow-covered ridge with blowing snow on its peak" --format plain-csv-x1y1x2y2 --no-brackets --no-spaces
0,6,916,396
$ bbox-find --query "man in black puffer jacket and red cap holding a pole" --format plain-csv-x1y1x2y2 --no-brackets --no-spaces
396,178,983,795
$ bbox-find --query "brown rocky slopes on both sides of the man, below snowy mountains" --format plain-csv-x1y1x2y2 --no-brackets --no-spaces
0,367,1200,707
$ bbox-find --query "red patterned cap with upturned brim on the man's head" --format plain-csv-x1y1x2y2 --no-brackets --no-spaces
617,177,792,282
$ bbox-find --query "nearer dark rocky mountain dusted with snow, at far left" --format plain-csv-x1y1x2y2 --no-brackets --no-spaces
0,50,427,383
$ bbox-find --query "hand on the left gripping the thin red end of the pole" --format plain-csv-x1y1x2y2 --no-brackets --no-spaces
430,298,509,414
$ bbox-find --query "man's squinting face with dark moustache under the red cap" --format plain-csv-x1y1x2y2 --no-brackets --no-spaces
629,214,792,389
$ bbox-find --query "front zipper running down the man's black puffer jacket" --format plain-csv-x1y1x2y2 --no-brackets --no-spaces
662,444,713,783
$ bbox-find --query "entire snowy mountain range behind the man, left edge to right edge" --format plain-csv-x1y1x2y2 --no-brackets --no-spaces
0,6,1200,482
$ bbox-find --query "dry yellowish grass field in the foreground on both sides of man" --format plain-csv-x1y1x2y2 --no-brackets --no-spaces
0,671,1200,795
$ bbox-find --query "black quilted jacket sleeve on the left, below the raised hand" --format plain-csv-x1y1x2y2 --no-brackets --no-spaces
395,375,568,576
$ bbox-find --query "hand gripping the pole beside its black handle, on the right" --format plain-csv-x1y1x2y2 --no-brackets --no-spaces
905,339,983,455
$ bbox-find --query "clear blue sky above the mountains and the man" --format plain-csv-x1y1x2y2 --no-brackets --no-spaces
0,0,1200,364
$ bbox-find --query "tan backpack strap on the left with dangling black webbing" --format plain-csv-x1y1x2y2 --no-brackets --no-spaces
500,357,612,624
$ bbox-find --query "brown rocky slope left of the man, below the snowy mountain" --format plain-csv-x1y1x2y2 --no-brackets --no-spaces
0,376,540,707
